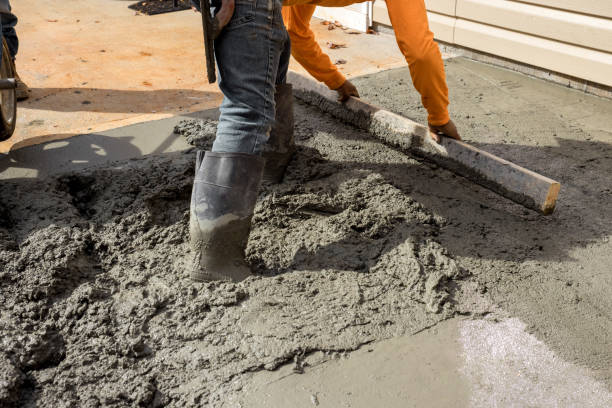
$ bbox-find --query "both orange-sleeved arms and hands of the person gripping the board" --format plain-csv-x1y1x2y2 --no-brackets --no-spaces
283,0,461,140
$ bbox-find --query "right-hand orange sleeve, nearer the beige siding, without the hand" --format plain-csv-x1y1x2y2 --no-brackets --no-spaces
386,0,450,126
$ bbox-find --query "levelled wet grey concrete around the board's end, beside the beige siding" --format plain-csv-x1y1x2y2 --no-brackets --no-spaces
356,58,612,386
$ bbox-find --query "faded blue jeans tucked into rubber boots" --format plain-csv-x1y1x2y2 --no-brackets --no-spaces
212,0,291,155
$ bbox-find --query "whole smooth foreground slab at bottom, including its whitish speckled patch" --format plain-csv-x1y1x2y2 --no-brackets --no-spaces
239,318,612,408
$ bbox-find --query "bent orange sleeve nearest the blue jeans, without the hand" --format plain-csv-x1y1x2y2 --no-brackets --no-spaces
283,4,346,89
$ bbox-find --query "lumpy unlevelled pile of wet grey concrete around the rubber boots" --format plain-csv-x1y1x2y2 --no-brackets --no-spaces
0,105,469,407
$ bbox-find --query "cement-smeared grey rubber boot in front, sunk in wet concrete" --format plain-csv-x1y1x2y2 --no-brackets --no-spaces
189,151,264,281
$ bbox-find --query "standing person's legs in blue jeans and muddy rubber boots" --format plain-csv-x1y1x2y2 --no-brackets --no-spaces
190,0,295,281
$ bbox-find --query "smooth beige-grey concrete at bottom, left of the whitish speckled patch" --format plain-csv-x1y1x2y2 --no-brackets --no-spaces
234,319,469,408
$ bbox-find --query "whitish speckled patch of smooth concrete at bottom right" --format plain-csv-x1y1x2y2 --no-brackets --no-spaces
459,318,612,408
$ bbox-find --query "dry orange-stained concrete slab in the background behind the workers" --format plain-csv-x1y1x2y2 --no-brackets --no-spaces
0,0,405,153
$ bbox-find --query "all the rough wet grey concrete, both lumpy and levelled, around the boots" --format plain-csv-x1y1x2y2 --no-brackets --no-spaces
0,60,612,407
